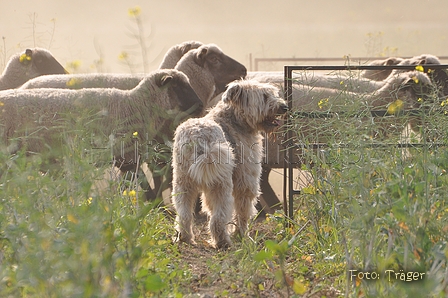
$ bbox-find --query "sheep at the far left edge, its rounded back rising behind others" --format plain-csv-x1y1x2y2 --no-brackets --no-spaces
0,48,67,90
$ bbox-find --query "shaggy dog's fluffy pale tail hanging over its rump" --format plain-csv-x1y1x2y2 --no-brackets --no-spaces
188,142,235,187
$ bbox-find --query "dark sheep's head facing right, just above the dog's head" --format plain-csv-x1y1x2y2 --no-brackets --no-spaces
195,44,247,94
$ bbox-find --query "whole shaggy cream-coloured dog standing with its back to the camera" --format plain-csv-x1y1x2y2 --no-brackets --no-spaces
172,80,287,248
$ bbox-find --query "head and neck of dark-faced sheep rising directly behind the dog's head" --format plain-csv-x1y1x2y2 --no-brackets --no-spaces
175,44,247,108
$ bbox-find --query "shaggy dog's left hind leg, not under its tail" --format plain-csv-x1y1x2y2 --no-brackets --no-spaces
172,185,198,244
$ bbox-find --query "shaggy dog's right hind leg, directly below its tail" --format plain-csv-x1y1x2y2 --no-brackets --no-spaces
202,184,234,248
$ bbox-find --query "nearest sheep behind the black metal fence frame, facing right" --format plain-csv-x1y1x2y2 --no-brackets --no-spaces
261,71,433,211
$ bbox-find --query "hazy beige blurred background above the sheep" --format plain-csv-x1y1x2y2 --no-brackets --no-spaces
0,0,448,72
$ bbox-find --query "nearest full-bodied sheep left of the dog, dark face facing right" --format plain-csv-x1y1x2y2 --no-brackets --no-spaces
0,70,202,200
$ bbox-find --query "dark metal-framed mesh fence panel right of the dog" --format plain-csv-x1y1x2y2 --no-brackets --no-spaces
283,65,448,218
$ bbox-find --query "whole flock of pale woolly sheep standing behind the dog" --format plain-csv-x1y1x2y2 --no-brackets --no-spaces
0,41,448,211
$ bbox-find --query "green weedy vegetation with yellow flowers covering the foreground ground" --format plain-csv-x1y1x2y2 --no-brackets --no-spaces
0,75,448,297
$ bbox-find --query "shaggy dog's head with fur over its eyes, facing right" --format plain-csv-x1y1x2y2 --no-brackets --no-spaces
222,80,288,132
